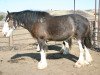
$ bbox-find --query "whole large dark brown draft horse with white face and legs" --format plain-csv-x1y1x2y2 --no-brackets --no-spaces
2,10,92,69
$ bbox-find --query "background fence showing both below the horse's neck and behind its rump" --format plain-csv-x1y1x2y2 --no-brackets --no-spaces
0,21,100,50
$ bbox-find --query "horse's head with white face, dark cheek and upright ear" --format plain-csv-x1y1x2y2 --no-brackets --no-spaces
2,11,16,37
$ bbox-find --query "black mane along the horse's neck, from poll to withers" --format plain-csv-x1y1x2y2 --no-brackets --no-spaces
10,10,50,25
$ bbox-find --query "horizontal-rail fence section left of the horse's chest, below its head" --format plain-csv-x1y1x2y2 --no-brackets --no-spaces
0,27,36,50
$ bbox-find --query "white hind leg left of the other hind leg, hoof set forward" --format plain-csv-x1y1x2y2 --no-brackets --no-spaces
75,40,85,68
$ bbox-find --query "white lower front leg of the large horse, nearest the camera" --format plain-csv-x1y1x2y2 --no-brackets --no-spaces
38,49,47,69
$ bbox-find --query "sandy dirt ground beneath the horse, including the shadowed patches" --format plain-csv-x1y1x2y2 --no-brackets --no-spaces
0,41,100,75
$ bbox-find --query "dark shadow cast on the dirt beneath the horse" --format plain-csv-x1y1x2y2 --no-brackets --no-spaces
11,45,78,62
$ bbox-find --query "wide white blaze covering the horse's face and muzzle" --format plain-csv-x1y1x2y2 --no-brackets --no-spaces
2,22,13,37
